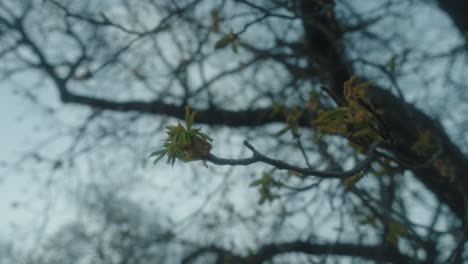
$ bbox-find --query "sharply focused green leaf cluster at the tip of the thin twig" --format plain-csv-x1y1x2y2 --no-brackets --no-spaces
150,106,213,165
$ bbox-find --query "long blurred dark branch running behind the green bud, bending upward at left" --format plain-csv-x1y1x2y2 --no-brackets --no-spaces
14,12,313,127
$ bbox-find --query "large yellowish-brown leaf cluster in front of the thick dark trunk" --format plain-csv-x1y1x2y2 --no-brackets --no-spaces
314,76,383,145
